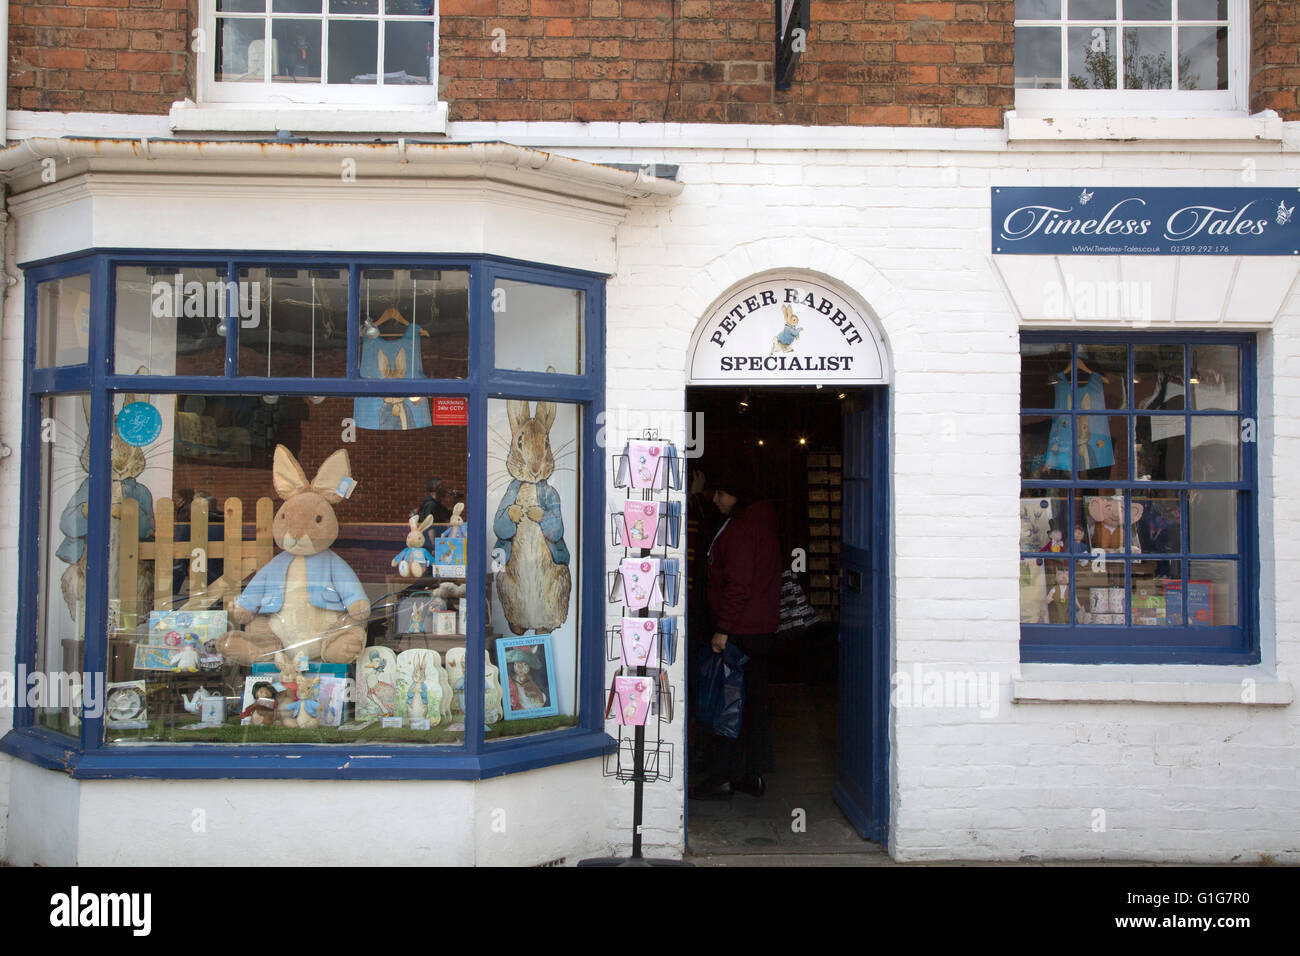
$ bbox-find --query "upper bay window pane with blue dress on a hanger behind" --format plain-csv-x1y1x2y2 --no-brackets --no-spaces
360,269,469,382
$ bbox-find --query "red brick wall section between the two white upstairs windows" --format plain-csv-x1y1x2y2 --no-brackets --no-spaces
441,0,1014,126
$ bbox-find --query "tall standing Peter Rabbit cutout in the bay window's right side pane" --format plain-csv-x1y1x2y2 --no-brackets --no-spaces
488,401,577,635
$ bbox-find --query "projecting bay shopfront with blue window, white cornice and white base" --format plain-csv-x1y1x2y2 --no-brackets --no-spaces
4,140,680,864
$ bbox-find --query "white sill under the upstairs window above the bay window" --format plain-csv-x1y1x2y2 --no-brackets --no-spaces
168,100,447,134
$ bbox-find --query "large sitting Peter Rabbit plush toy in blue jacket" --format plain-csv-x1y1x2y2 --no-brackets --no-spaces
218,445,371,665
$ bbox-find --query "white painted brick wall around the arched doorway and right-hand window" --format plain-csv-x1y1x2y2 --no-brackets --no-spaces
592,132,1300,862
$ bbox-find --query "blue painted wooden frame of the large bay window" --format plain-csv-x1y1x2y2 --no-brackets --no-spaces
0,248,612,779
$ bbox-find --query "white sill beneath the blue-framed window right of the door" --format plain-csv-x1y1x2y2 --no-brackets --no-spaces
1011,663,1295,708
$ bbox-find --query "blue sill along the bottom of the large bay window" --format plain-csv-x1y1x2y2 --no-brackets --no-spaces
0,728,612,780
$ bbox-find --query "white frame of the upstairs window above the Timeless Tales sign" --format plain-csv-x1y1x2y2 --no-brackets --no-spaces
1013,0,1251,116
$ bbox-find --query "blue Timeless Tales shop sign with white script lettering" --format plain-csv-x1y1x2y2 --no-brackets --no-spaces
992,186,1300,256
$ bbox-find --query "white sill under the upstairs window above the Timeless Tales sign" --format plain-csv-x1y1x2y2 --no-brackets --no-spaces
1006,109,1282,143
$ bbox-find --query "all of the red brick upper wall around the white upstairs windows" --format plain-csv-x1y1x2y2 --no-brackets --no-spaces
9,0,1300,126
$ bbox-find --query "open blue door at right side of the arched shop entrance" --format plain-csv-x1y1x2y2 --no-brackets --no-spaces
832,388,889,843
